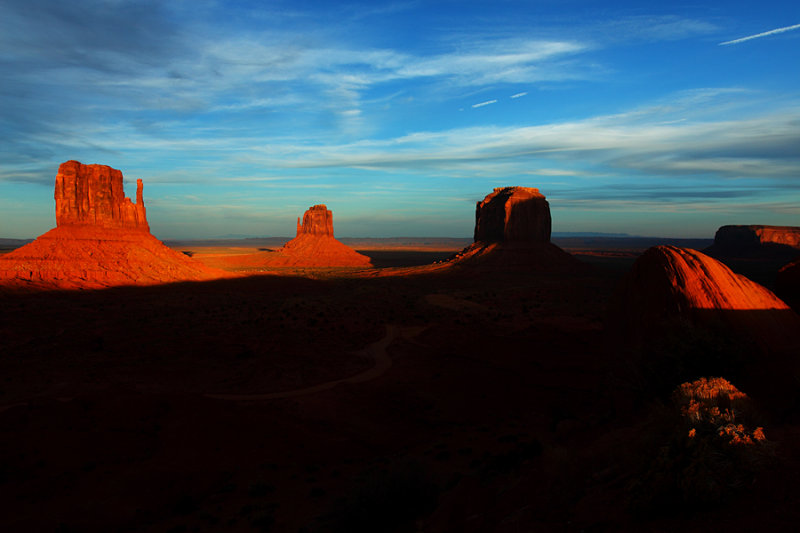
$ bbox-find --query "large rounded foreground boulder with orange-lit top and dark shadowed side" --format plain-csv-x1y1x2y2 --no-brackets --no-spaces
609,246,800,404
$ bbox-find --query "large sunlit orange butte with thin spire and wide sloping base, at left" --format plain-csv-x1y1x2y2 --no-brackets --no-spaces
0,161,230,289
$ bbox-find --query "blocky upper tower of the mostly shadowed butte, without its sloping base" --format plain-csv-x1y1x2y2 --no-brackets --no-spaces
475,187,551,243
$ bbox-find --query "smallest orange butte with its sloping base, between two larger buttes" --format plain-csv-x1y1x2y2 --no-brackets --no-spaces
259,204,372,267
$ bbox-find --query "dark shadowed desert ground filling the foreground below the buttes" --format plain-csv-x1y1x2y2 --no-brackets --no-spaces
0,242,800,532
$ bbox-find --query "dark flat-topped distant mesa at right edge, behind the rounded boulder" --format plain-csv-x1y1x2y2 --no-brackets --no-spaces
707,225,800,257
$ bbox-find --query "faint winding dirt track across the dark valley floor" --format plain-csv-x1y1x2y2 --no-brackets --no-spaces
204,324,425,401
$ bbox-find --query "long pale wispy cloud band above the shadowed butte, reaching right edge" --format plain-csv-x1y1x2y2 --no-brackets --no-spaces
265,90,800,179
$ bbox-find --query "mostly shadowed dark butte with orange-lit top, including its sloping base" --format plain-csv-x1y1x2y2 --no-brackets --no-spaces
449,187,580,270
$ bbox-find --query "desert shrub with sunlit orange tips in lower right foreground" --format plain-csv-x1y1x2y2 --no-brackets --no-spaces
629,378,774,517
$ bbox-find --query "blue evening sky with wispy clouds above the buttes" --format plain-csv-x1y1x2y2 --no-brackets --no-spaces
0,0,800,239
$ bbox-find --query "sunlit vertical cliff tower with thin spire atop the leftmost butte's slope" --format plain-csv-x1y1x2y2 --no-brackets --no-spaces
55,161,150,232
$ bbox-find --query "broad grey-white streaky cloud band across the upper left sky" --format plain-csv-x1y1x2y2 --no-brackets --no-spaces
0,0,592,164
